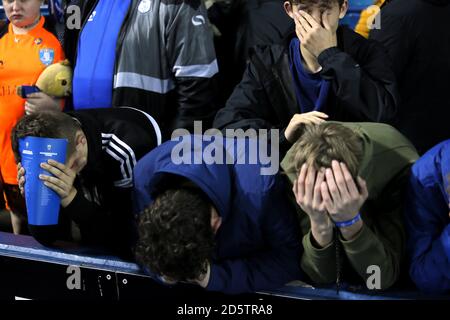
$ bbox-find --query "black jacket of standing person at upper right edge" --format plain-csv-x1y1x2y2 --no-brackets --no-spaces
370,0,450,153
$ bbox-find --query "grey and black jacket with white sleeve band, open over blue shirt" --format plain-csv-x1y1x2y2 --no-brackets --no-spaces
64,0,217,138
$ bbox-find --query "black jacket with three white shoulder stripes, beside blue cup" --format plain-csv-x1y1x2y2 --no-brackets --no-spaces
60,108,161,255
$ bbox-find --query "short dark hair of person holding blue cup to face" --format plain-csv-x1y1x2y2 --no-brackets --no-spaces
11,110,81,162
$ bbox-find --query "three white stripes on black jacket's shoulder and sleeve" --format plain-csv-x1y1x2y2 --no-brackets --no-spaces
102,133,137,188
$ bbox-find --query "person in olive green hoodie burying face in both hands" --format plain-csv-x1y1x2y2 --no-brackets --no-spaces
282,122,418,289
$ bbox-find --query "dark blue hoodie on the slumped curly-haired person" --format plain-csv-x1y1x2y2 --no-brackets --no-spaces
134,136,301,294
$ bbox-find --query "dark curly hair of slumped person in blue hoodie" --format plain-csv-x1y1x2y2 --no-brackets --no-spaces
135,188,215,281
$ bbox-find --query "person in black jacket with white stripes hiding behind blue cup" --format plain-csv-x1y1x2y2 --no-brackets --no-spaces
12,108,161,257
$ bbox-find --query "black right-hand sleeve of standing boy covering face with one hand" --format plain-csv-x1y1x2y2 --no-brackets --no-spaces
318,40,398,122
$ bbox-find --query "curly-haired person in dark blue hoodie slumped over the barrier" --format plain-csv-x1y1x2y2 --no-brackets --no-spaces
135,136,301,294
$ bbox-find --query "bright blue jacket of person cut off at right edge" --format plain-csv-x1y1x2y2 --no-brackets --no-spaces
406,140,450,293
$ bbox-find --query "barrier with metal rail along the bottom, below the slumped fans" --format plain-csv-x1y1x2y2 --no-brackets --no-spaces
0,233,450,303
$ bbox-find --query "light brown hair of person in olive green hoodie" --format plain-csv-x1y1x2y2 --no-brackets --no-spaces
294,122,364,178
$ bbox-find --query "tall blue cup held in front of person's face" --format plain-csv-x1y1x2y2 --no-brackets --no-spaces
19,137,68,245
